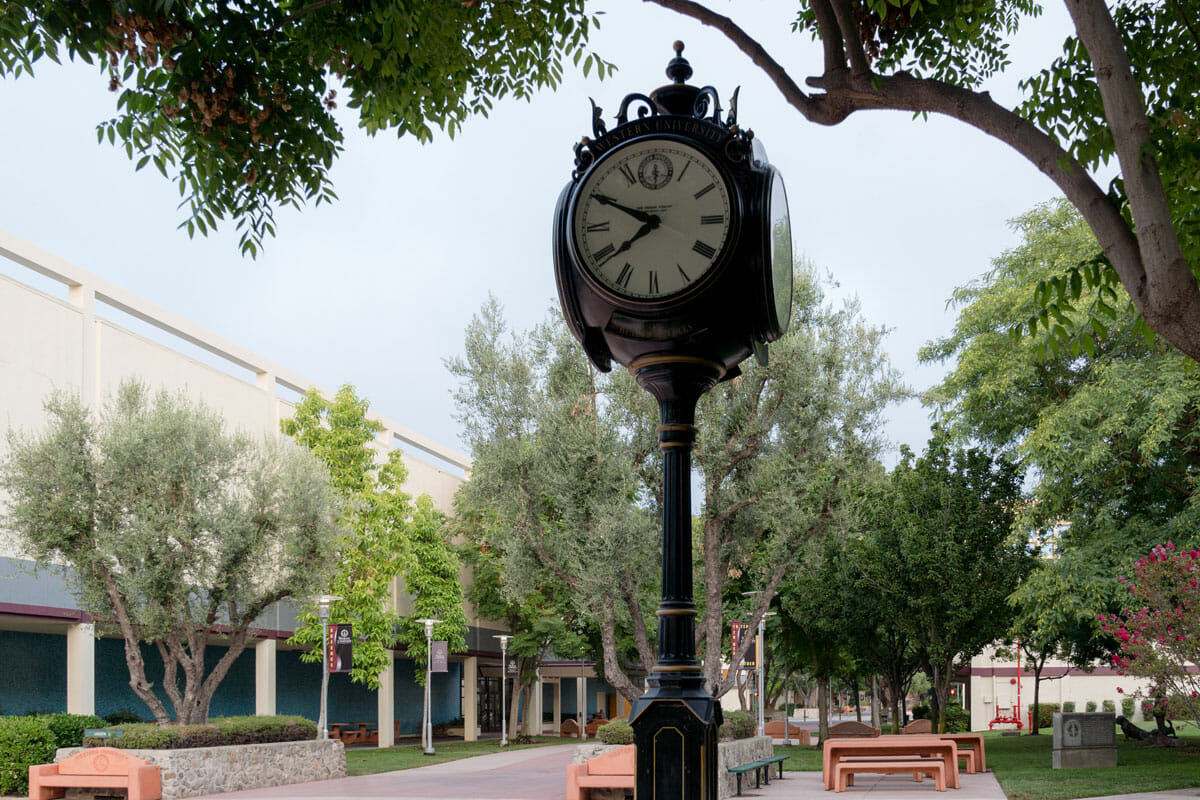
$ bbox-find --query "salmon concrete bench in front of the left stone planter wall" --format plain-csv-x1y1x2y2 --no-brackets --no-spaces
29,747,162,800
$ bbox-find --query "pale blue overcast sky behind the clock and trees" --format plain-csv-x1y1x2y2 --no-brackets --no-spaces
0,0,1069,464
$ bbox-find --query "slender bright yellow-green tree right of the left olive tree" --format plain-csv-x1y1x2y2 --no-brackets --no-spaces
280,385,467,688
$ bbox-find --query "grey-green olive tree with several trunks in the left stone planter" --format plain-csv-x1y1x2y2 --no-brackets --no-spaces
0,381,336,724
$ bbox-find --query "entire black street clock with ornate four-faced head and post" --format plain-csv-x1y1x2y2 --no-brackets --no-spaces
553,42,792,800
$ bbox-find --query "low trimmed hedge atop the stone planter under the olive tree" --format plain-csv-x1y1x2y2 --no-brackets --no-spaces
83,716,317,750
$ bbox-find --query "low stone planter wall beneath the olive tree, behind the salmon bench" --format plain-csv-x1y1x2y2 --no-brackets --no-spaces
54,739,346,800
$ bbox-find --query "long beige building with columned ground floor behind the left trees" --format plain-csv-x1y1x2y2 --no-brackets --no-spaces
0,231,612,746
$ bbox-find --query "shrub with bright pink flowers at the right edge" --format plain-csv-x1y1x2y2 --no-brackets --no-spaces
1099,542,1200,726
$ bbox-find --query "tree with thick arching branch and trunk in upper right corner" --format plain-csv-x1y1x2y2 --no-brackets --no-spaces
650,0,1200,359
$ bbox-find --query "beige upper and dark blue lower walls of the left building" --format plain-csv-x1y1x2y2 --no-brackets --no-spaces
0,231,477,733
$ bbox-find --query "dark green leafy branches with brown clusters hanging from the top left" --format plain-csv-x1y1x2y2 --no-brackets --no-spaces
0,0,610,255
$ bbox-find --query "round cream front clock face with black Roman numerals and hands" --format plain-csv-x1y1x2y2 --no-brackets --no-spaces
571,139,733,302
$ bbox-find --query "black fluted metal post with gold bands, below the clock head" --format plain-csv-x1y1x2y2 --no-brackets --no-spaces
629,354,725,800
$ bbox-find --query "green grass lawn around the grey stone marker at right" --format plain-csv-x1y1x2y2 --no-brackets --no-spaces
775,728,1200,800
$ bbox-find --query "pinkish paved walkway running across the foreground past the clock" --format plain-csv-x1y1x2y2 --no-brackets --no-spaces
187,744,1200,800
